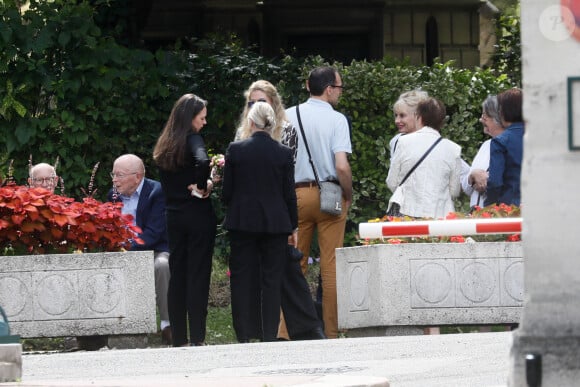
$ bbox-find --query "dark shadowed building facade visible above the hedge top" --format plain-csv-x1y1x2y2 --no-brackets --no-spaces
137,0,498,67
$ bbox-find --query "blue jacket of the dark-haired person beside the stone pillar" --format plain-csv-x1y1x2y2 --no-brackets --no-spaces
485,122,525,206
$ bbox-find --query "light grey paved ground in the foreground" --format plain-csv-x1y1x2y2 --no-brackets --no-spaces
2,332,512,387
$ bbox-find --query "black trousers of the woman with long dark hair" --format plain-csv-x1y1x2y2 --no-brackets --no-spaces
166,208,217,347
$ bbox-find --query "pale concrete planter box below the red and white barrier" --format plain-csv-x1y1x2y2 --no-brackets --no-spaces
336,242,524,336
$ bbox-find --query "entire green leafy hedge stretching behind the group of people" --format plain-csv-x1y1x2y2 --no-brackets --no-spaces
0,0,513,249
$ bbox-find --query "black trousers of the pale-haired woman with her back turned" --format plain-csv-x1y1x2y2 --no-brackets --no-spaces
229,231,288,341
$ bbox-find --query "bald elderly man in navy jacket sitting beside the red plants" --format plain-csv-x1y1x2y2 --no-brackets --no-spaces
107,154,171,345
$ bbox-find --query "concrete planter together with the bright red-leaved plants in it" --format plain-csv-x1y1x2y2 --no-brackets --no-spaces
0,184,156,338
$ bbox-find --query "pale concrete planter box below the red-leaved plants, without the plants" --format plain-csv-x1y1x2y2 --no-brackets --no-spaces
0,251,156,338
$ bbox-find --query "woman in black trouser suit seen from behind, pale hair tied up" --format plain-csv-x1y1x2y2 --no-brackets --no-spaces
222,102,298,342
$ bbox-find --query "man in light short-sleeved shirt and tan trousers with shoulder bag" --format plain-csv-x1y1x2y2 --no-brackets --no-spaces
286,66,352,338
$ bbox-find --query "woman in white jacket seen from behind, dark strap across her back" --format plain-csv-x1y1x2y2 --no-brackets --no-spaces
387,98,462,219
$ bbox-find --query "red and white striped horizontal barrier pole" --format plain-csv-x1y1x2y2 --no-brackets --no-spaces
358,218,522,239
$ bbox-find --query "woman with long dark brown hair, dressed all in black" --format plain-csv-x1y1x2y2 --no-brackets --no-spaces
153,94,217,347
